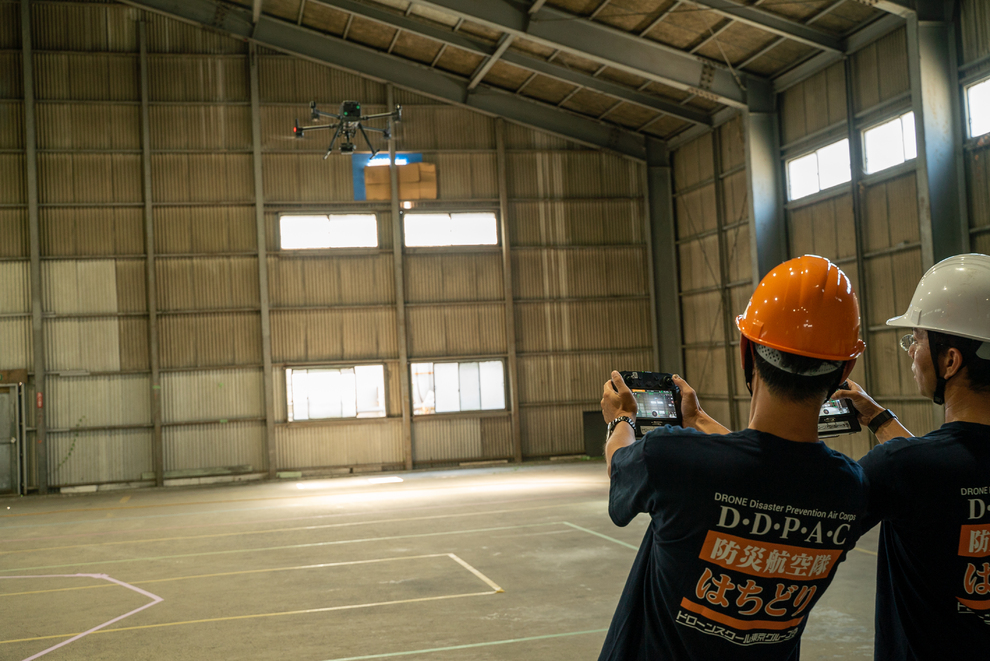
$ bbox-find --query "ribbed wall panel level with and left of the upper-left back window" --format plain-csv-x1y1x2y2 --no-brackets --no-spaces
154,205,258,255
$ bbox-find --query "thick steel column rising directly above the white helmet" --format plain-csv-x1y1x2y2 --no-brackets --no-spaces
907,5,969,270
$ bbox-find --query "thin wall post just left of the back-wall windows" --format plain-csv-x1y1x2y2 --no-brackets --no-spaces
248,42,278,479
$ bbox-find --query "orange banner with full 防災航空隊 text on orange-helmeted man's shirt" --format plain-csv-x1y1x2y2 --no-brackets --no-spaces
698,530,842,581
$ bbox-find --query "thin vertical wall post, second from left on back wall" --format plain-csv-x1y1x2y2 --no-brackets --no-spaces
138,16,165,487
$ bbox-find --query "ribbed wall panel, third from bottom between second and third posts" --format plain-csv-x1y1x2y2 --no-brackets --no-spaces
158,312,261,368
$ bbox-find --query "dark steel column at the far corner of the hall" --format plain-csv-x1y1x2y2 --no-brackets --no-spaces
646,138,684,374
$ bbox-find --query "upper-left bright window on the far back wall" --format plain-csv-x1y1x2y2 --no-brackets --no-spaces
279,214,378,250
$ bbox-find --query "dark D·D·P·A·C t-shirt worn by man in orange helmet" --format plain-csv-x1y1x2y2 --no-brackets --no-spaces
599,426,867,661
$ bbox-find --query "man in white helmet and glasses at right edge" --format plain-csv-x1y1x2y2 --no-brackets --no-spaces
835,254,990,661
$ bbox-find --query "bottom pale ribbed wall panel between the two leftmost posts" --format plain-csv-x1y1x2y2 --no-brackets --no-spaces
47,429,153,487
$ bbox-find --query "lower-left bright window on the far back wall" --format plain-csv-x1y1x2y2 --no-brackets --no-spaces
285,365,385,422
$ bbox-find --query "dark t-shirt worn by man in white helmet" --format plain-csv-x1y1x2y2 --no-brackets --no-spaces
860,422,990,661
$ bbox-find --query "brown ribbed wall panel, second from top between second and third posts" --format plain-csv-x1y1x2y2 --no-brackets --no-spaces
148,55,250,102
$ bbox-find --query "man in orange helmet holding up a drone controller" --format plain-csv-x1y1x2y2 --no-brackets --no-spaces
599,255,867,661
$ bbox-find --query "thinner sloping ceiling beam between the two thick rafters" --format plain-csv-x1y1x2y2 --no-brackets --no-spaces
309,0,711,126
